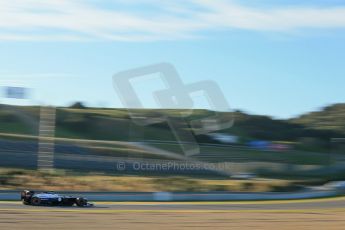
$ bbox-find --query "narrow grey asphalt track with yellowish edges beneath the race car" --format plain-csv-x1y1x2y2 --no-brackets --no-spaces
0,197,345,213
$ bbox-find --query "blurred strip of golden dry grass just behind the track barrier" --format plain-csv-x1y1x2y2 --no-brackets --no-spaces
0,169,294,192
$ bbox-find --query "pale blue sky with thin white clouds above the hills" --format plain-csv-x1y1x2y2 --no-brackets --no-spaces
0,0,345,118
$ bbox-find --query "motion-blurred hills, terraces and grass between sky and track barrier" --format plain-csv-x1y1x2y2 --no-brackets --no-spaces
0,87,345,192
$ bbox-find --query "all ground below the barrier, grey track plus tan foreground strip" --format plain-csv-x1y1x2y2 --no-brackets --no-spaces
0,198,345,230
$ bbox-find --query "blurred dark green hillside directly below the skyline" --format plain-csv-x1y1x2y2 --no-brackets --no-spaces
0,104,345,149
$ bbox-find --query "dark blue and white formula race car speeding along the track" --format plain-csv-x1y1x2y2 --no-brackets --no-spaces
20,190,93,207
